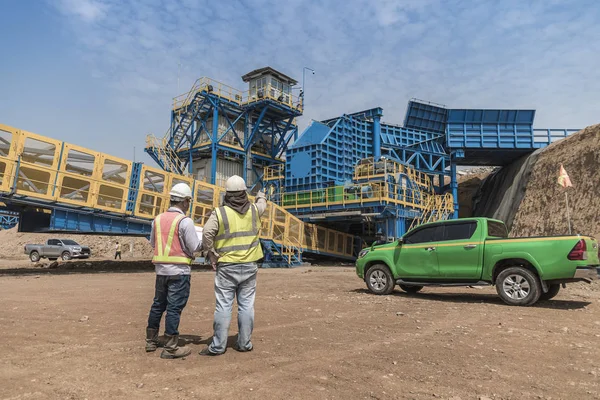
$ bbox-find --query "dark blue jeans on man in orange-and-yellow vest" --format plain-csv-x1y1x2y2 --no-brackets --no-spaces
148,275,190,336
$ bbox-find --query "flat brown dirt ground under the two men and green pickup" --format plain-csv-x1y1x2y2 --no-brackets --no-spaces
0,267,600,400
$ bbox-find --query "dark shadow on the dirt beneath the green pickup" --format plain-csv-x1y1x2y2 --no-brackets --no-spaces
351,289,592,310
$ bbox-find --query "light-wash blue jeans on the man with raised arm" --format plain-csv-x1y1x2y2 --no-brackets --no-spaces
208,262,258,354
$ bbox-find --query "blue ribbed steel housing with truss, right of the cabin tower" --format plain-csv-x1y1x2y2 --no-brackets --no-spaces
285,108,450,192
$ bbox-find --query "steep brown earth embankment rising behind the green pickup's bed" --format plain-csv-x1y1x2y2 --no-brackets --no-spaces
511,124,600,238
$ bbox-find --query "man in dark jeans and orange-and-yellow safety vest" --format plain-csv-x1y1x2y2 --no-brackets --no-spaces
146,183,202,358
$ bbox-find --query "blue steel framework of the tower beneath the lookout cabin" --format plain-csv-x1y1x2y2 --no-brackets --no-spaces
145,73,302,189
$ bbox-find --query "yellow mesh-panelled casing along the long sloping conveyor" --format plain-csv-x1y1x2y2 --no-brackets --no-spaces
0,124,353,259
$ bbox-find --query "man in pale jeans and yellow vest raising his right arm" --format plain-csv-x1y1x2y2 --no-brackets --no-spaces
200,175,267,356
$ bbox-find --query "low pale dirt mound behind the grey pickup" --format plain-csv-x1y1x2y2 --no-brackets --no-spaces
0,228,152,260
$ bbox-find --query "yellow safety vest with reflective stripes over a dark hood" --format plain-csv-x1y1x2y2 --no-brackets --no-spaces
215,204,263,263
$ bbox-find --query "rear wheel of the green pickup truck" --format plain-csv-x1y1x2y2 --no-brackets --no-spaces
496,267,542,306
